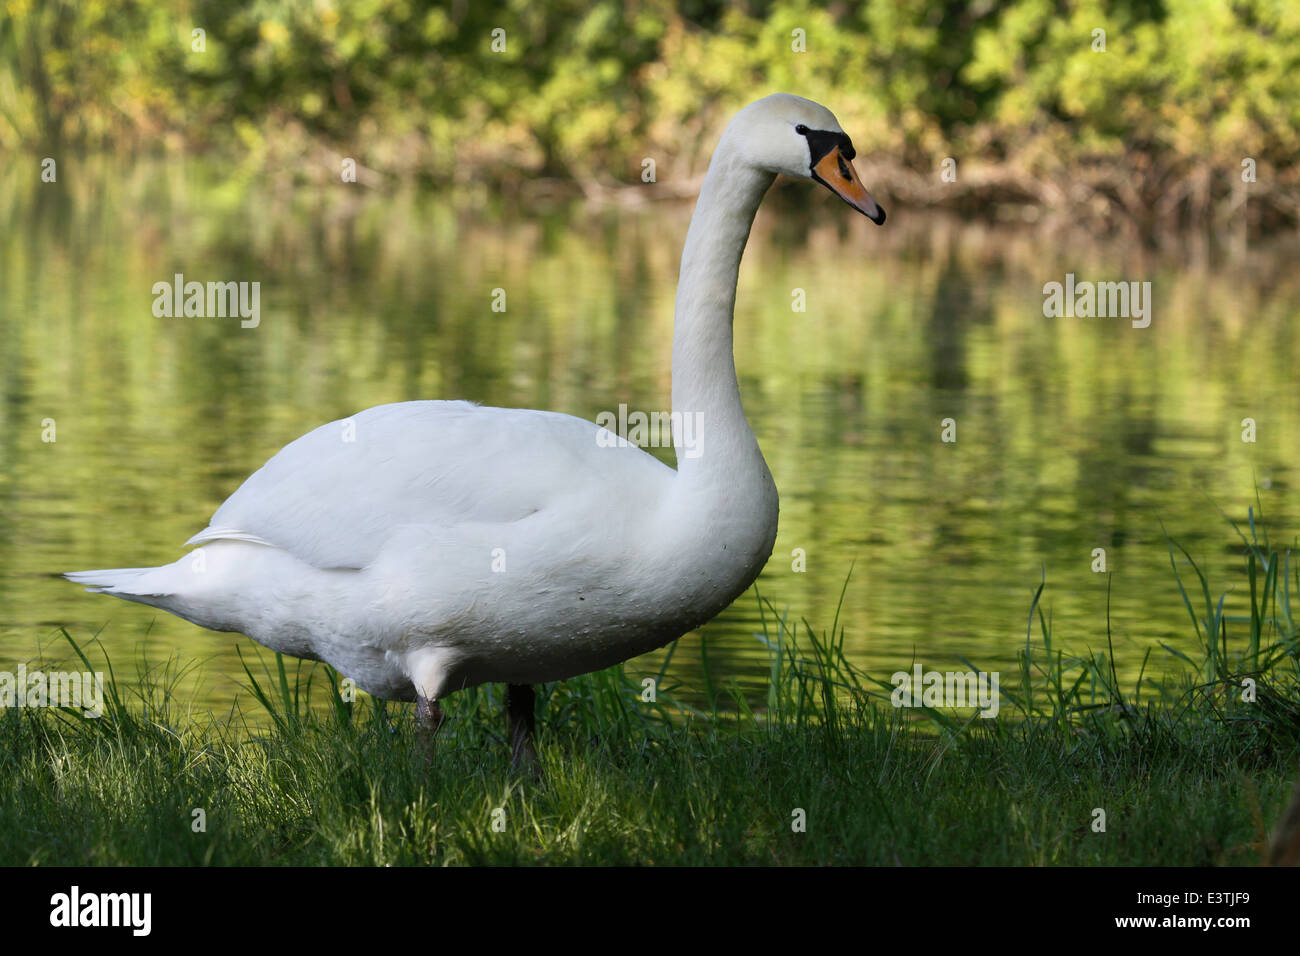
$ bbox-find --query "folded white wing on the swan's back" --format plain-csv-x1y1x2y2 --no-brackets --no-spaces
187,402,672,568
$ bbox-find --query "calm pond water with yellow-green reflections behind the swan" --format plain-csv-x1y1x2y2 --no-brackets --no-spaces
0,161,1300,710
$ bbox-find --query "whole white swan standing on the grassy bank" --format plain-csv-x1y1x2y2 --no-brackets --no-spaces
65,94,885,758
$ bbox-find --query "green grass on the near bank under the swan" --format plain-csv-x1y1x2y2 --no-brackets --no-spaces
0,515,1300,866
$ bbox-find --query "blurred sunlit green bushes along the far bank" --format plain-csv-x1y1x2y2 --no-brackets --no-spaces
0,0,1300,220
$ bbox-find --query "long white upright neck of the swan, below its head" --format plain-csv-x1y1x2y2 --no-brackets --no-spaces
672,143,776,496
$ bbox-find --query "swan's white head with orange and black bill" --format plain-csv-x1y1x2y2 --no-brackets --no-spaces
727,92,885,225
